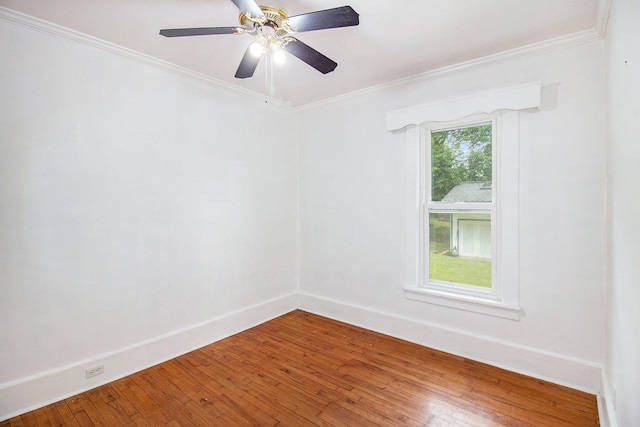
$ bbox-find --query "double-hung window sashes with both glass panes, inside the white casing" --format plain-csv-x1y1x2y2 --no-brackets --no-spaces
428,121,496,296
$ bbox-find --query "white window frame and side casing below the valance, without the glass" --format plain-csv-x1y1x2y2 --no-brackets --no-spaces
403,111,521,320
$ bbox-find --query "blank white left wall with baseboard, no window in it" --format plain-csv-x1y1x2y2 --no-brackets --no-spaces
0,12,297,419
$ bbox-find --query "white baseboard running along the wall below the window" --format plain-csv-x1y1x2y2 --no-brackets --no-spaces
299,293,602,394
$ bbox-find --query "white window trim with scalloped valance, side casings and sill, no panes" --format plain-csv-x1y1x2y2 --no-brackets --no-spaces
387,81,542,320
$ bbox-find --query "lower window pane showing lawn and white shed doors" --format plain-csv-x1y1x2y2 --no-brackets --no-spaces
429,210,491,288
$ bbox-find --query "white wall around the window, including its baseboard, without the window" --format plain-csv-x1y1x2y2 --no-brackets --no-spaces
299,41,606,391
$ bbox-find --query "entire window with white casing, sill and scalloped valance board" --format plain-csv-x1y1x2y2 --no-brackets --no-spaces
387,82,542,320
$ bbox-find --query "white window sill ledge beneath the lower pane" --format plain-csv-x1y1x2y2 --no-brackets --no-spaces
404,286,521,320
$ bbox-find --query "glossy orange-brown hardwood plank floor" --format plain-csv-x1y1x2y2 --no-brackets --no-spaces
0,310,598,427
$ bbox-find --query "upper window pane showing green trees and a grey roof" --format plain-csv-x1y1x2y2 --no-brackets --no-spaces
431,123,493,202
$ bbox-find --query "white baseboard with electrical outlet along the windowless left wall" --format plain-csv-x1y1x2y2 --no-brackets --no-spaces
0,294,298,421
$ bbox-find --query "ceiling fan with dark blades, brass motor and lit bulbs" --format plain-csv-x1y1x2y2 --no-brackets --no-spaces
160,0,360,79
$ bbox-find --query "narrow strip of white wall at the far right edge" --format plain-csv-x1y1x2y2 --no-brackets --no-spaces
606,0,640,426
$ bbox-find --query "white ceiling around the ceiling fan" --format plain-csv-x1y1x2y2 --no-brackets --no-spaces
0,0,606,106
